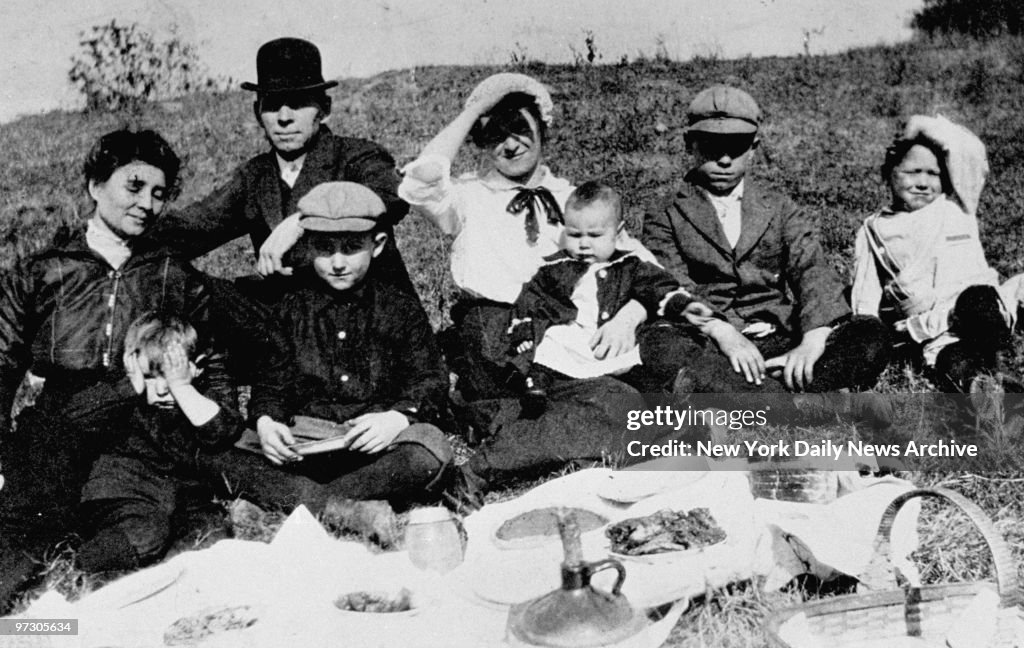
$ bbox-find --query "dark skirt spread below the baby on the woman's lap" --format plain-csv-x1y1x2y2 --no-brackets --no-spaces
468,368,663,488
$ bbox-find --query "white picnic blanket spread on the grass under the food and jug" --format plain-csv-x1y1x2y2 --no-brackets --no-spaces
9,469,915,648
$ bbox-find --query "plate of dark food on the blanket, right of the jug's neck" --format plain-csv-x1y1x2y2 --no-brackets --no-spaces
605,507,726,562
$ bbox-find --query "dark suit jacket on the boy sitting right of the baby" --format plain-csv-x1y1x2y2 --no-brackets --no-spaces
642,175,850,335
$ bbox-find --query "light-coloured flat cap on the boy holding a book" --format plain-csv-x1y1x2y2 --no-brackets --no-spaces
299,182,386,231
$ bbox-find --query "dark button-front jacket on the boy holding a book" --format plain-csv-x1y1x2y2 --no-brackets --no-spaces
249,273,449,424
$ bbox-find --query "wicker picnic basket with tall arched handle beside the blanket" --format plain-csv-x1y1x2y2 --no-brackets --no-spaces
766,488,1019,648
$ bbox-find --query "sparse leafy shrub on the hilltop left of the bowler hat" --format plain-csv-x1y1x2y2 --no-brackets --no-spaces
68,19,226,111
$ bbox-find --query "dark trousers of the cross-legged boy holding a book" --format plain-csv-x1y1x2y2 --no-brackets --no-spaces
200,424,444,514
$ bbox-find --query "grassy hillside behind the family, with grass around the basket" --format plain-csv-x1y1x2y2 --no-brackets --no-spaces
6,34,1024,646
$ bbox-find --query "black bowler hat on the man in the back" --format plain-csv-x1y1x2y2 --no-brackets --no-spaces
242,38,338,94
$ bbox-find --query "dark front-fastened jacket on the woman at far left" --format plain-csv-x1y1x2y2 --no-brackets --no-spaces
0,231,222,440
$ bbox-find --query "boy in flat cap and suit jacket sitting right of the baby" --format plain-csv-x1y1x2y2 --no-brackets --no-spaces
641,86,889,409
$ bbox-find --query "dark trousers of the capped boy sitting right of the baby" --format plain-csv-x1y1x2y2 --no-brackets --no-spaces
639,315,892,393
